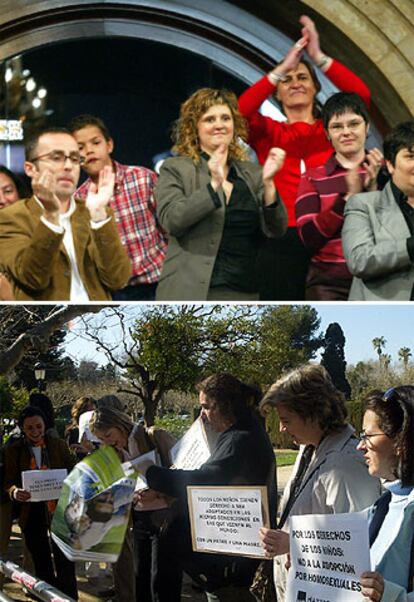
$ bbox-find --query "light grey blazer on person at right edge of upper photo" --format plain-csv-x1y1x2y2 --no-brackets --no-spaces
342,183,414,301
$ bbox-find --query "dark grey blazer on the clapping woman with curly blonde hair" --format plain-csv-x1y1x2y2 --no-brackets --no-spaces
155,157,287,301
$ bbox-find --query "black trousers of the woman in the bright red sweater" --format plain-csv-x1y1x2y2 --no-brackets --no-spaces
257,228,309,301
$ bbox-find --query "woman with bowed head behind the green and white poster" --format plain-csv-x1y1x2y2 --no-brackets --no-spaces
89,403,175,602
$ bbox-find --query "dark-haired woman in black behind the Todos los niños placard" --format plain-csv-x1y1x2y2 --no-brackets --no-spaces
142,374,276,602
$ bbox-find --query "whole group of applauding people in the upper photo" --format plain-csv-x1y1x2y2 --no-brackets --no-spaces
0,16,414,302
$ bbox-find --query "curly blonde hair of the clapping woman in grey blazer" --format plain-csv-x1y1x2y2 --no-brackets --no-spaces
172,88,248,163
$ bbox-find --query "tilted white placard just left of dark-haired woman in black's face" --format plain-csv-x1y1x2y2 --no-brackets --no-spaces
170,418,210,470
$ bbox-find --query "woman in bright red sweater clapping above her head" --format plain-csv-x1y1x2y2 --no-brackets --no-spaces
239,16,371,301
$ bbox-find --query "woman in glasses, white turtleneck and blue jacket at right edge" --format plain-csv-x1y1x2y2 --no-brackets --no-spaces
358,386,414,602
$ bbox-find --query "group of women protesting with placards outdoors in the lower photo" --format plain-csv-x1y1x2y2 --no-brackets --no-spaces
2,365,414,602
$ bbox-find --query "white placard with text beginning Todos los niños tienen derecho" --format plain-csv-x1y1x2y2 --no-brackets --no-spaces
187,487,269,558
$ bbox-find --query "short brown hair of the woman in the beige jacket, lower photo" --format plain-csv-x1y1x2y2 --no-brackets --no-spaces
260,364,348,434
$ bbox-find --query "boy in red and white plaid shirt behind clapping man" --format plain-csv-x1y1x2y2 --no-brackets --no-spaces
68,115,167,301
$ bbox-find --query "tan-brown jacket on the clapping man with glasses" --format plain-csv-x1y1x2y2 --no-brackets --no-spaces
0,197,131,301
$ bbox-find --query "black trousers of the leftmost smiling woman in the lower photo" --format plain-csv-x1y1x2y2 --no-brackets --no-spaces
23,502,78,600
